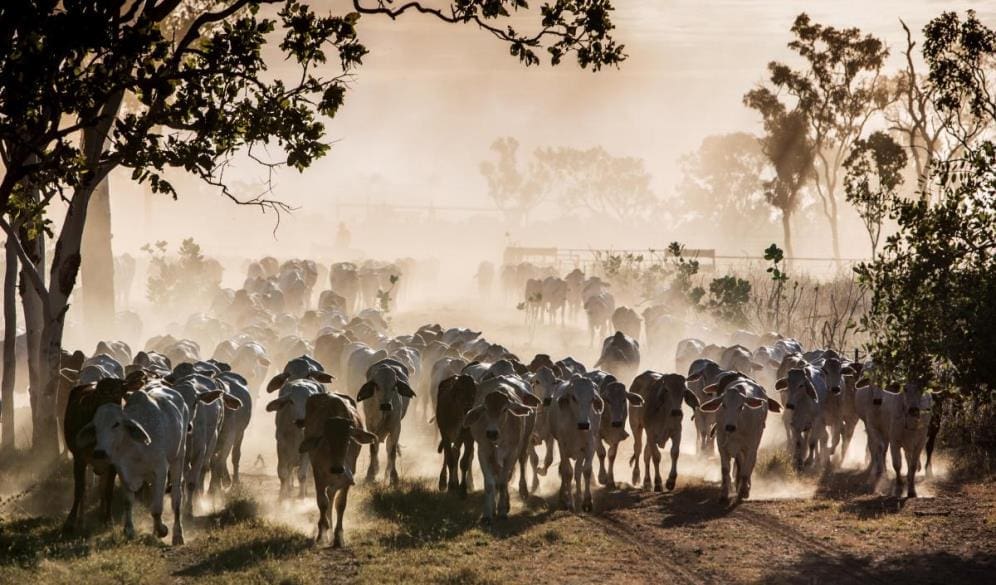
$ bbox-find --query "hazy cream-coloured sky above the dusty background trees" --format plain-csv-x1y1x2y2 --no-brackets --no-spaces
109,0,996,256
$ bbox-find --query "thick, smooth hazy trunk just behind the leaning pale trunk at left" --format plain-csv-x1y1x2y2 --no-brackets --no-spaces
80,178,115,338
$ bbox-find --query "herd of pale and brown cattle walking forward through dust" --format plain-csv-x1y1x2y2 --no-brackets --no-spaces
48,259,937,546
